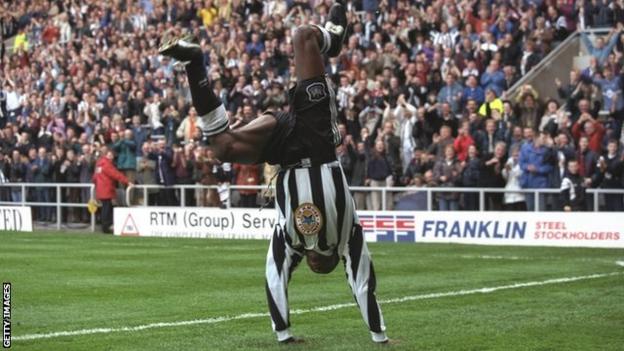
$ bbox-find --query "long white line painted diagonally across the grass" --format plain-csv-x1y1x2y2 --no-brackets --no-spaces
12,272,624,340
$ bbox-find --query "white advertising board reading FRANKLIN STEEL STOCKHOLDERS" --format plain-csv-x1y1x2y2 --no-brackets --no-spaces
359,211,624,248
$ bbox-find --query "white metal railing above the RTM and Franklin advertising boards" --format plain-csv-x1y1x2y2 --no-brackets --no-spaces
126,184,624,212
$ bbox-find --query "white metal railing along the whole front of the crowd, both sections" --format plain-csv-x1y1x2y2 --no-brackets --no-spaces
0,183,624,235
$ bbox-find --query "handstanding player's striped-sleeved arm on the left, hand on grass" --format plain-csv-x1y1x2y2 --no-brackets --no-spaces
266,225,303,342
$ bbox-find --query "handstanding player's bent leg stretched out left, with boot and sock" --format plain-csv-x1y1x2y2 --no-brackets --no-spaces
159,36,276,163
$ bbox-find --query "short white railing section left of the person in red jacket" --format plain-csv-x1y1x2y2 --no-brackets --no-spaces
0,183,95,232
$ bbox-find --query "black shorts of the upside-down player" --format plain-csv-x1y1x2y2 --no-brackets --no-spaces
262,76,340,166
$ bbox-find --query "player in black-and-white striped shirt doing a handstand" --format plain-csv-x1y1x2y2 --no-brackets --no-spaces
159,3,388,343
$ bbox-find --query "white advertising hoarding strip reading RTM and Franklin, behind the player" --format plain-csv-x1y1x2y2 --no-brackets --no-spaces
114,207,624,248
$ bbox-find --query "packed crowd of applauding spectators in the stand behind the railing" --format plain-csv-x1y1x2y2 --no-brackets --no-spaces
0,0,624,226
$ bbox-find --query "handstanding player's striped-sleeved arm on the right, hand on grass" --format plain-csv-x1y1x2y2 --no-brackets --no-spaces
343,224,388,343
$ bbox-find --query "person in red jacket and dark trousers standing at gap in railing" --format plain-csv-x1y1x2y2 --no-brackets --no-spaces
93,146,131,233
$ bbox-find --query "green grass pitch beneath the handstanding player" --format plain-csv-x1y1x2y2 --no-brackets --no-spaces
0,232,624,351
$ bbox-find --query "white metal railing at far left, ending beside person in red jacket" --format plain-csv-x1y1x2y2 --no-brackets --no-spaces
0,183,95,232
